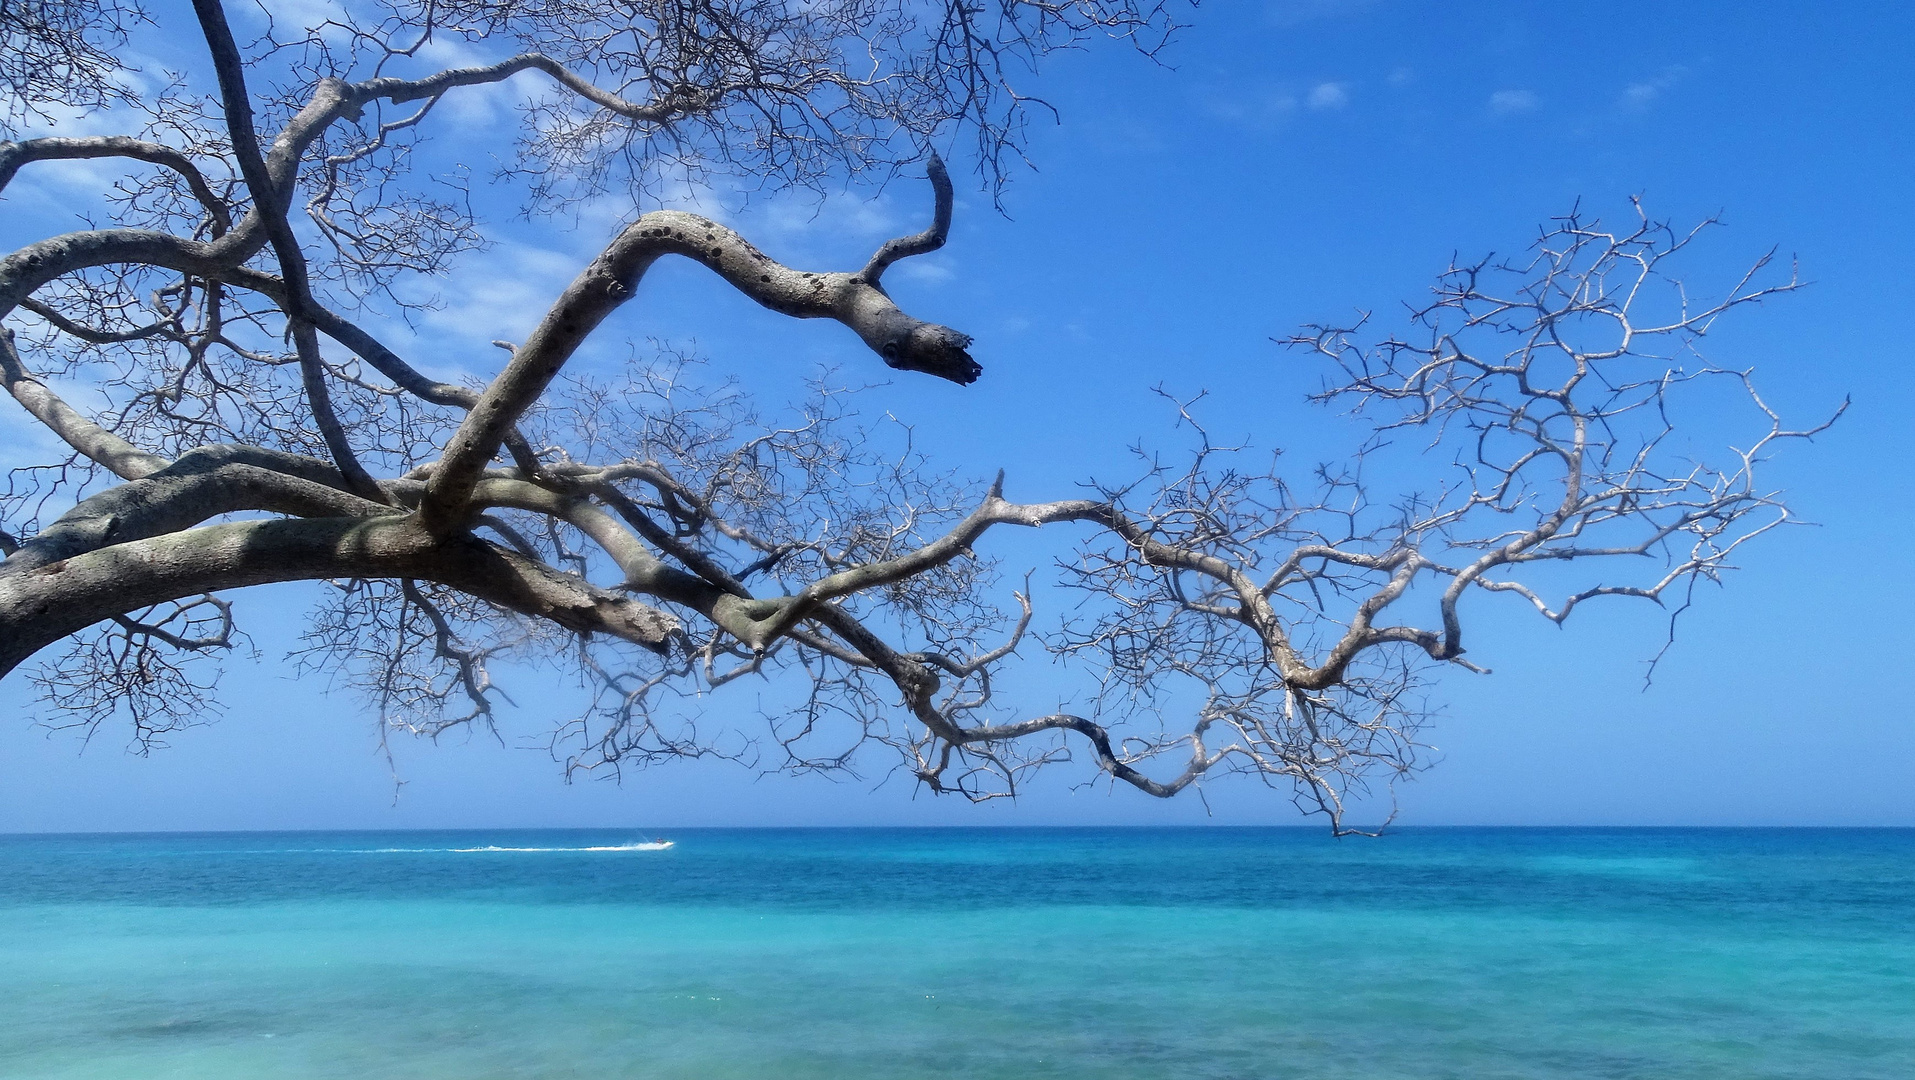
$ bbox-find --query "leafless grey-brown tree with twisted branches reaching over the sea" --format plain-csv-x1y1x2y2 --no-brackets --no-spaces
0,0,1819,831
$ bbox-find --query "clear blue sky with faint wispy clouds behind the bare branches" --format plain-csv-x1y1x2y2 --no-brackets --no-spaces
0,0,1915,831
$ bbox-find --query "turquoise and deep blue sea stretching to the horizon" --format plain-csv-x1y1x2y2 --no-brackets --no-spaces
0,829,1915,1080
